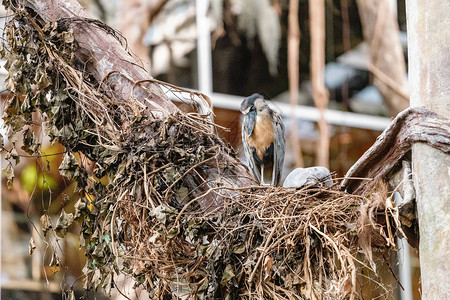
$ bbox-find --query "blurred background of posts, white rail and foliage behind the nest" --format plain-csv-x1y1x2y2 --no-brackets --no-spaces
0,0,420,300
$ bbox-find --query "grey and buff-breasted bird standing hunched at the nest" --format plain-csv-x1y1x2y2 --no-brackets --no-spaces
240,93,286,186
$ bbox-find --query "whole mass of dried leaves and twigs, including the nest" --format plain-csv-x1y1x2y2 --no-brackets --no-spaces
2,4,398,299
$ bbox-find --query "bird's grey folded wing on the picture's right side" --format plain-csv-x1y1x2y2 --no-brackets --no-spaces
272,113,286,186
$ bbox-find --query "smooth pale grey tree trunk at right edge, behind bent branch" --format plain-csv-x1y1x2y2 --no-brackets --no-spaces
407,0,450,299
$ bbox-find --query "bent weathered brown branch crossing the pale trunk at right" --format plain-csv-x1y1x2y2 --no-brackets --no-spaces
341,108,450,195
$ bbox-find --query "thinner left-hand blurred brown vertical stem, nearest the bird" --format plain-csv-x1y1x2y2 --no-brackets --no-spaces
288,0,304,168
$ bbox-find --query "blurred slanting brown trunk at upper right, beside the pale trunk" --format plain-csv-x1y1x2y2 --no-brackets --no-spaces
357,0,409,117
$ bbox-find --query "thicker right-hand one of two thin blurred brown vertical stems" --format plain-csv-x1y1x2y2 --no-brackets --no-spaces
309,0,330,168
